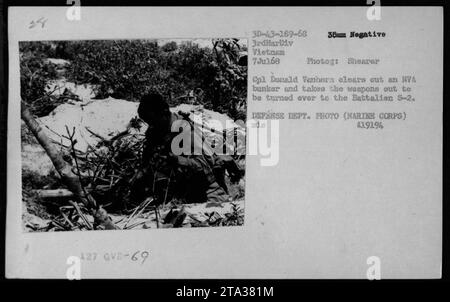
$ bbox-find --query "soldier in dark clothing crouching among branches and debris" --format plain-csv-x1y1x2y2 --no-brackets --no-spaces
132,94,243,203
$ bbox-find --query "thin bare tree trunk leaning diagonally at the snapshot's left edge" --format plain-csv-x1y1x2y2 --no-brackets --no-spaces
21,102,116,230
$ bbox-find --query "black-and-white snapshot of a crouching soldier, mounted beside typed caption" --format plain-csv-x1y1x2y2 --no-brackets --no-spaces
19,38,247,232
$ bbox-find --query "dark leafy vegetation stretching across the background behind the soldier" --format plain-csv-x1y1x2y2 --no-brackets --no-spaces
20,39,247,120
